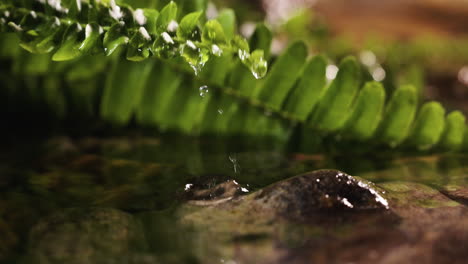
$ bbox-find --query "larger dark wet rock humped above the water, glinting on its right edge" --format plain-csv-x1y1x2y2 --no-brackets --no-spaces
255,170,388,216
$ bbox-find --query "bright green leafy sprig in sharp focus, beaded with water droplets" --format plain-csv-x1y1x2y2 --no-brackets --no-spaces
0,0,267,78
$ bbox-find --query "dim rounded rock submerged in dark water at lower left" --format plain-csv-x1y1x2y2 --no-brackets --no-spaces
24,208,144,264
